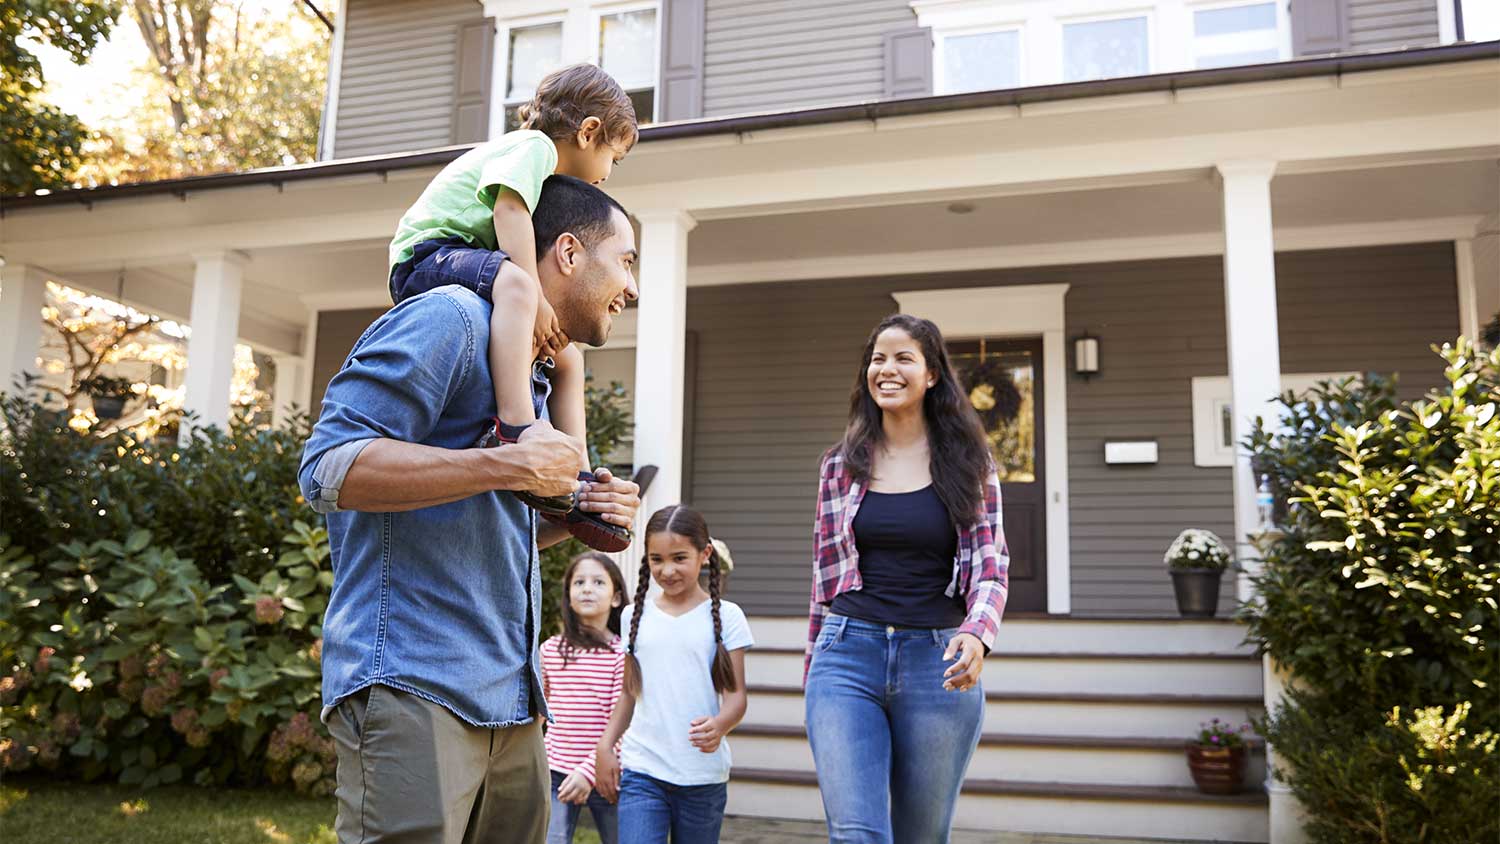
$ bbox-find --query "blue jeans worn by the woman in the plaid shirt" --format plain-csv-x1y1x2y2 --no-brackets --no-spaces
806,615,984,844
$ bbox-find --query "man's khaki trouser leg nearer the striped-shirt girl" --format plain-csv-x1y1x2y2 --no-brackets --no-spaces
464,718,552,844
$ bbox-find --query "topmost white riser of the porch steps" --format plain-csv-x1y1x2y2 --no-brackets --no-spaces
750,613,1254,655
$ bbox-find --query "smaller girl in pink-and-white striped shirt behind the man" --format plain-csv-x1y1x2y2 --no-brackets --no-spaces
542,552,626,844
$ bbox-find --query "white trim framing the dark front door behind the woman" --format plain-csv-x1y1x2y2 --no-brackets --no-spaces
891,285,1073,615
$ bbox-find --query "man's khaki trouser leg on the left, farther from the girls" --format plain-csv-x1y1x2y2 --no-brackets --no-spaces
329,685,489,844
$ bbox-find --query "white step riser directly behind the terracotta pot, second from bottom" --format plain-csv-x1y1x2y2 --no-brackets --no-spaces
729,724,1266,789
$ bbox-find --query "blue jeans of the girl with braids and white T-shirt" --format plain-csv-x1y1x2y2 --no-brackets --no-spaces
620,771,729,844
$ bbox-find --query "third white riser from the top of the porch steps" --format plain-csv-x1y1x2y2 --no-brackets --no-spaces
747,684,1265,739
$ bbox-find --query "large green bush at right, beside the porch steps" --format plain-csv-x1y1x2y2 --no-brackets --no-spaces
1245,342,1500,843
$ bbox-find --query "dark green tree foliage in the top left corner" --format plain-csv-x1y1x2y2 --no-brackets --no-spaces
0,0,120,193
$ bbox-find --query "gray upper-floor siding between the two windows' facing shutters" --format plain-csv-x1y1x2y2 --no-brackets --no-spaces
704,0,917,117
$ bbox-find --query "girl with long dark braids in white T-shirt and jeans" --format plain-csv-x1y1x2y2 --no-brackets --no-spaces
596,504,755,844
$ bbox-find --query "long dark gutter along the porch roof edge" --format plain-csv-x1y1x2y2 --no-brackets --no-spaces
0,40,1500,217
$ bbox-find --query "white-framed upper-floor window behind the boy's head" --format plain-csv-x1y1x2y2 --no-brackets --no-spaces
485,0,660,136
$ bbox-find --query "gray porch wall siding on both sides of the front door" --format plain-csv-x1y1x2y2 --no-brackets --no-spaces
687,243,1458,615
